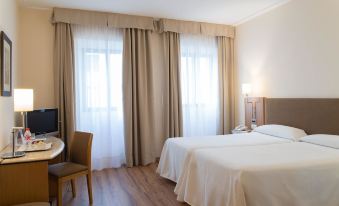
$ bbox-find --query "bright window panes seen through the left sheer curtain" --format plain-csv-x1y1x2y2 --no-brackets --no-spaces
82,49,122,110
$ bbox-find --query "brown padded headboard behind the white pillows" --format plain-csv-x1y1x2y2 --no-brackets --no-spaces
264,98,339,135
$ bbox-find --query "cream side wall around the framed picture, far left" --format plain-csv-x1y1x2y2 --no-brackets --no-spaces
0,0,18,150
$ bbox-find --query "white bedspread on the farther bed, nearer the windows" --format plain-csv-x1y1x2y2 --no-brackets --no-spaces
157,132,292,182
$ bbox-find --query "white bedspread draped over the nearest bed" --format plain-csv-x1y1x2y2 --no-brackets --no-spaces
175,142,339,206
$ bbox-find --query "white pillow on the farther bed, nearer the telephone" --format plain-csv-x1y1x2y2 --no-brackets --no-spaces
253,124,307,141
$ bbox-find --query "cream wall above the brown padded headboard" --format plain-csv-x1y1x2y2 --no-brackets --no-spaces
236,0,339,123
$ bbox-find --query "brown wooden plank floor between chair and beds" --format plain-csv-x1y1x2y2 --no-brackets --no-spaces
53,165,187,206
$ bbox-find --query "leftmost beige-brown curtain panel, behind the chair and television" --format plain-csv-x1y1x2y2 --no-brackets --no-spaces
54,23,75,153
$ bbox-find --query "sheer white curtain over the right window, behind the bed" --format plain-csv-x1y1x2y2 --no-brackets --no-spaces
180,34,219,136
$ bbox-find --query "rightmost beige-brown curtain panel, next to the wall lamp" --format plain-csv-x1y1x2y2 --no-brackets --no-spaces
217,37,235,134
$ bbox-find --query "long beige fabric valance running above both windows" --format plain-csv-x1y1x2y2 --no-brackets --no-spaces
52,8,235,38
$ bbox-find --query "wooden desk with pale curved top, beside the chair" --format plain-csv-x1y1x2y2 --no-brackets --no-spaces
0,137,65,206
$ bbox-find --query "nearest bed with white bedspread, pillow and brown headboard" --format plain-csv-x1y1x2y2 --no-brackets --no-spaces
175,99,339,206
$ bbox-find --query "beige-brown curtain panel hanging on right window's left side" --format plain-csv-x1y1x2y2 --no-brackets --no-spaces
163,32,183,138
